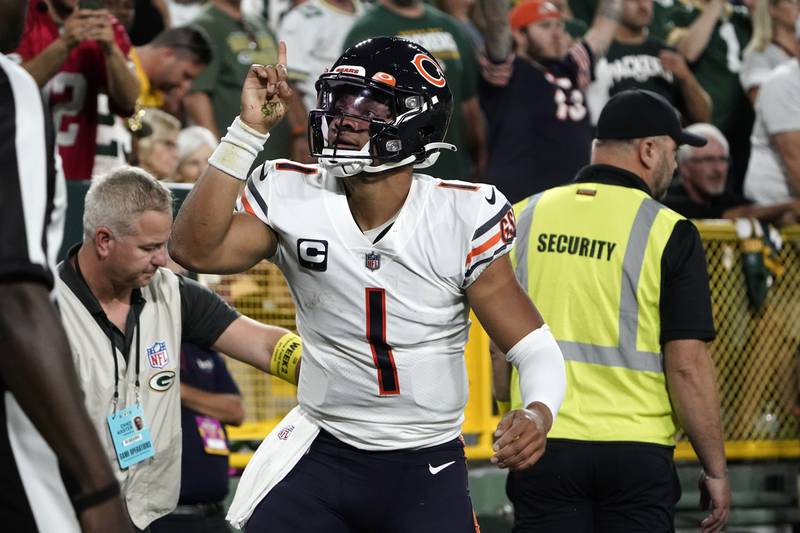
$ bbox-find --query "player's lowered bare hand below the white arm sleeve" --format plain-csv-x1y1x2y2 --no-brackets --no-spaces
491,403,550,470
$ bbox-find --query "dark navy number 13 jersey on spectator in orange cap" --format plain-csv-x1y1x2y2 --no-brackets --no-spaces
478,42,594,203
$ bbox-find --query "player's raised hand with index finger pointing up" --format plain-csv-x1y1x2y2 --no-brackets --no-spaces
244,41,292,133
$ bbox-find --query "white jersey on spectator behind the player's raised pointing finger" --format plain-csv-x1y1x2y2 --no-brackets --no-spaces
278,0,364,110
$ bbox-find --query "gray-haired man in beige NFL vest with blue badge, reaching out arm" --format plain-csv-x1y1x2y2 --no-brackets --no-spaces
56,167,301,530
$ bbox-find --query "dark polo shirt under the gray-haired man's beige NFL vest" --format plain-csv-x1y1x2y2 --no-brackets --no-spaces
58,244,239,359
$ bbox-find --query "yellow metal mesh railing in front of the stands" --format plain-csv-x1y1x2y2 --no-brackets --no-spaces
203,222,800,466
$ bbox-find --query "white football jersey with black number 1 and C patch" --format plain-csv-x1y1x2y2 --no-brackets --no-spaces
238,160,515,450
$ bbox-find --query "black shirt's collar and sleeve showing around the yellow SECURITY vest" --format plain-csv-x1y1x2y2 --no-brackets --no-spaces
576,165,716,345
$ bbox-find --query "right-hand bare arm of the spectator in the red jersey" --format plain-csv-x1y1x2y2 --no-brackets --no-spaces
87,10,140,116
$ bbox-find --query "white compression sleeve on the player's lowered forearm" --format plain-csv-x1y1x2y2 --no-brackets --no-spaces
506,324,567,422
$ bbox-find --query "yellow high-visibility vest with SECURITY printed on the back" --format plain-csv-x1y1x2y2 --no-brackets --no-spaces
511,183,683,445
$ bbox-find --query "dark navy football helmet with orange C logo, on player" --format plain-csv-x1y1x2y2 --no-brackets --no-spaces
309,37,456,177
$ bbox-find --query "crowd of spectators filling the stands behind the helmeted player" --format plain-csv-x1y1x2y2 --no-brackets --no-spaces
9,0,800,220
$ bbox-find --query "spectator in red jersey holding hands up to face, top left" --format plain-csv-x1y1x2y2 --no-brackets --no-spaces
11,0,139,180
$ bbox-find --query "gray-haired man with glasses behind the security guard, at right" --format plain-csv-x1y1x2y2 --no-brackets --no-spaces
664,123,800,222
